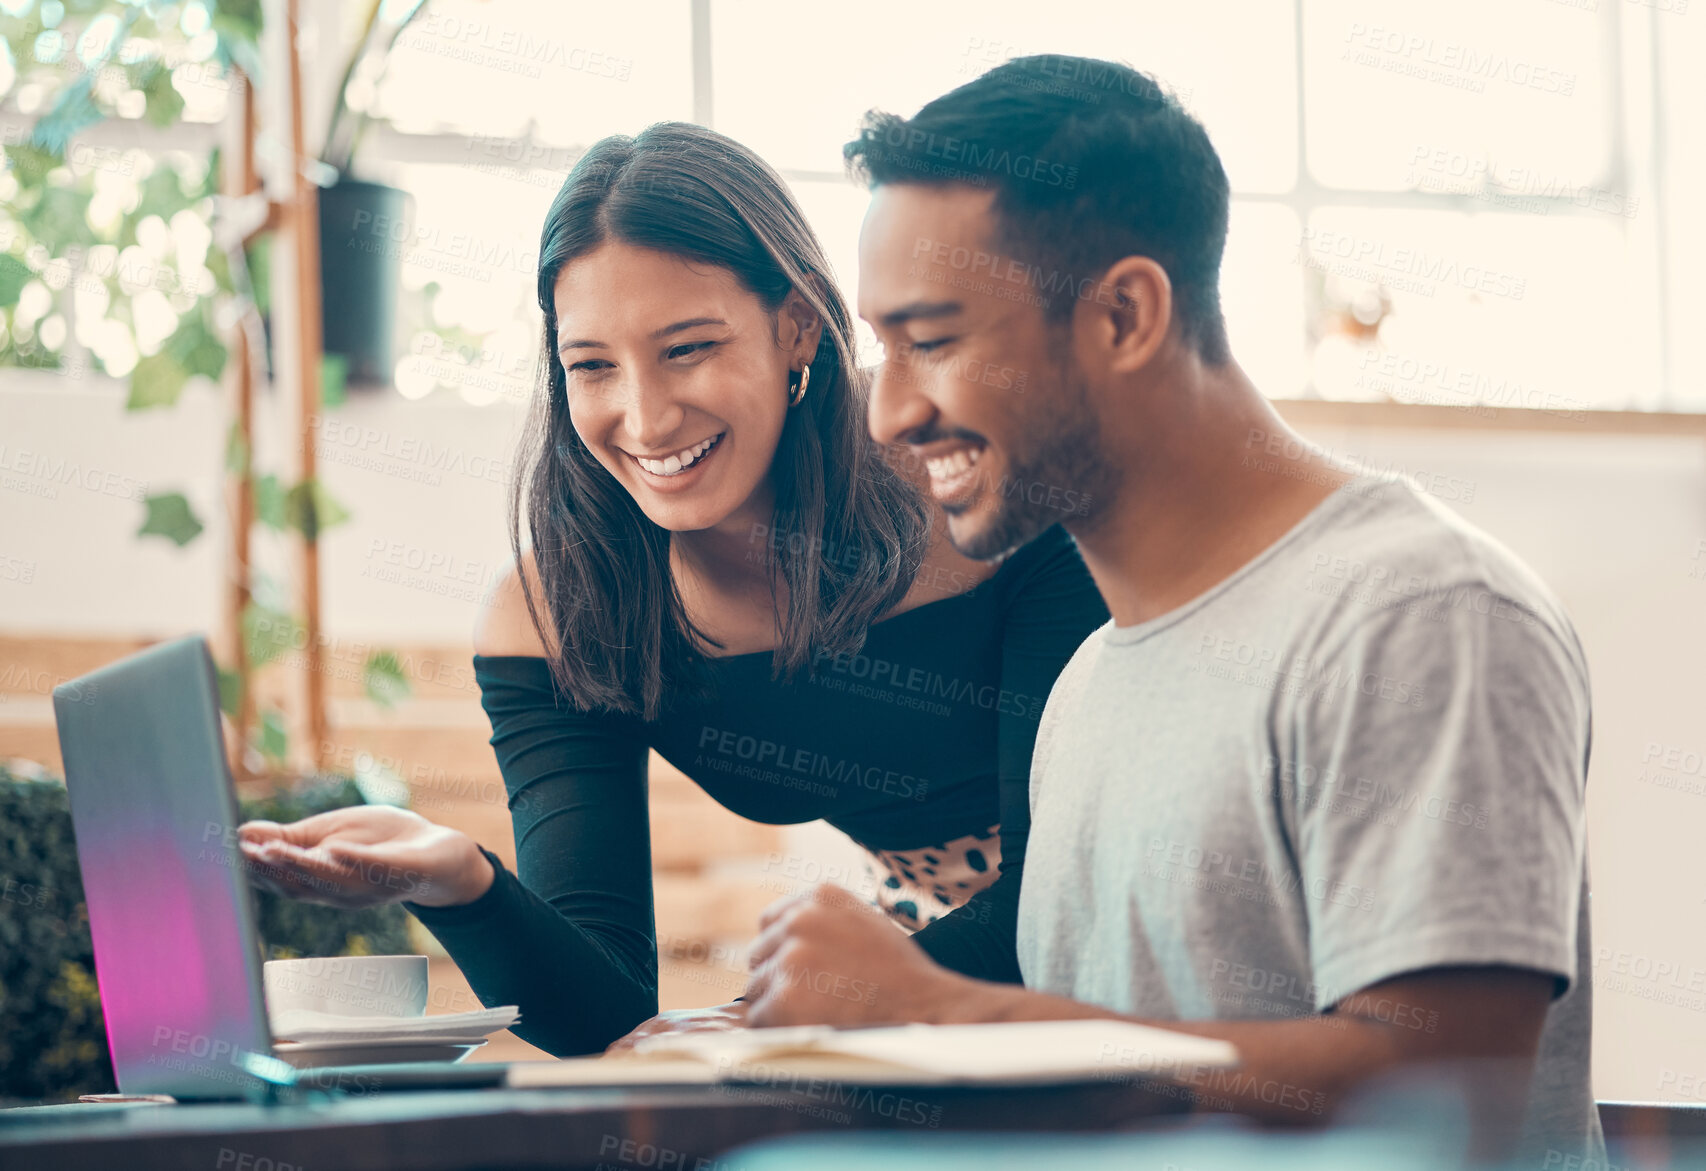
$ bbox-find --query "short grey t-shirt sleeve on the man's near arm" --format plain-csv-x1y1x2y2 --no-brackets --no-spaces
1271,591,1590,1009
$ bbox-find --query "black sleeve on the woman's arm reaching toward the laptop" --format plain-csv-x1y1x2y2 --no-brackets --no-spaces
404,655,657,1057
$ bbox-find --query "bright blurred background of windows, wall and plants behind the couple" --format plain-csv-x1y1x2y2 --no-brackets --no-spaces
0,0,1706,1101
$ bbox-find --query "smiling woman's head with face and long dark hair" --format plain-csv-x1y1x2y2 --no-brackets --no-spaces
528,123,928,719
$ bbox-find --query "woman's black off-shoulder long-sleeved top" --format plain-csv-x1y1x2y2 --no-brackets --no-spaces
406,526,1109,1057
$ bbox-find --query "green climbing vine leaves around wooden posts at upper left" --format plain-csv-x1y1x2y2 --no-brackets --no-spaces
0,0,420,770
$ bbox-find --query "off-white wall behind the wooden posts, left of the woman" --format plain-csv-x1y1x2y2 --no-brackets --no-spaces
0,370,520,642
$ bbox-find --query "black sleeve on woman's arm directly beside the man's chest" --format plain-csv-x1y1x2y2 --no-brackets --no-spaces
914,526,1107,983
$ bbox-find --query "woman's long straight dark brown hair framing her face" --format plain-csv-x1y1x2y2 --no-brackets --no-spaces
510,123,930,720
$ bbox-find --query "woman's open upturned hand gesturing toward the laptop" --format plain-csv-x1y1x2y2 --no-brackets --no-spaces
237,806,495,908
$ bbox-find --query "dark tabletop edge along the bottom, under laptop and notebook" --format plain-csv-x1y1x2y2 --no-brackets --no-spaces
0,1081,1184,1171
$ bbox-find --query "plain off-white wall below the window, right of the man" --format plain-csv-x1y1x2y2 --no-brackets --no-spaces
1289,419,1706,1099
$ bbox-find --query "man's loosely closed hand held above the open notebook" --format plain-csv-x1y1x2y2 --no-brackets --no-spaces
746,886,971,1026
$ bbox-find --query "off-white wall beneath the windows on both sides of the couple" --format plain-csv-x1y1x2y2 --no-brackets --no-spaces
0,372,1706,1099
